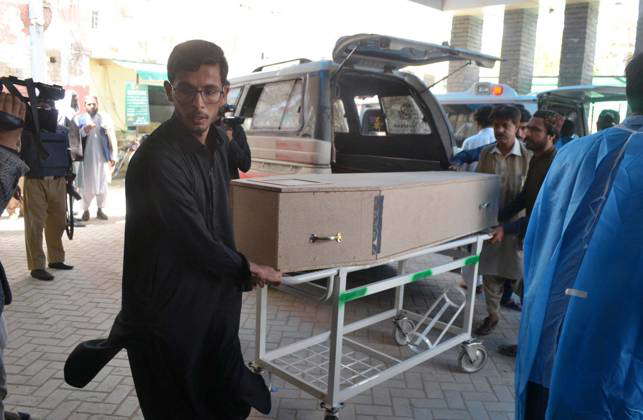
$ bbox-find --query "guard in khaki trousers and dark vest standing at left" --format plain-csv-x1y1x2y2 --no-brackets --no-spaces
21,99,73,281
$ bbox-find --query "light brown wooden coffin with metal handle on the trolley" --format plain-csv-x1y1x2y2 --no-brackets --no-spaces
231,172,500,272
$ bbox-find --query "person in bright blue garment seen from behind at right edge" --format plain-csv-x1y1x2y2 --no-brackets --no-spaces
516,54,643,420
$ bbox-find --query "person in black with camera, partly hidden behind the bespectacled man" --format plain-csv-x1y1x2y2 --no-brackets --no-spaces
217,80,252,179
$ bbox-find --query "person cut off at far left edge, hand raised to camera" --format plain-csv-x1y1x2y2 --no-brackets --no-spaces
0,93,29,420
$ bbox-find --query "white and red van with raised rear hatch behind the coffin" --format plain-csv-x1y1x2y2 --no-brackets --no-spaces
228,34,498,176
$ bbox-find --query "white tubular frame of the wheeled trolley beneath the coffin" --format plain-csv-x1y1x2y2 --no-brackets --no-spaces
251,234,490,419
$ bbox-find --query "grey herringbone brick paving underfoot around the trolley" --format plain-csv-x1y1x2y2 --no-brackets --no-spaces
0,181,518,420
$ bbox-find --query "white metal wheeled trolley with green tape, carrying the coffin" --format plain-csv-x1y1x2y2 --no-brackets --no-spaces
251,234,490,420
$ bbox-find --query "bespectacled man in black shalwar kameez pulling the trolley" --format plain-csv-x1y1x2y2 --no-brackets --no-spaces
65,41,281,420
